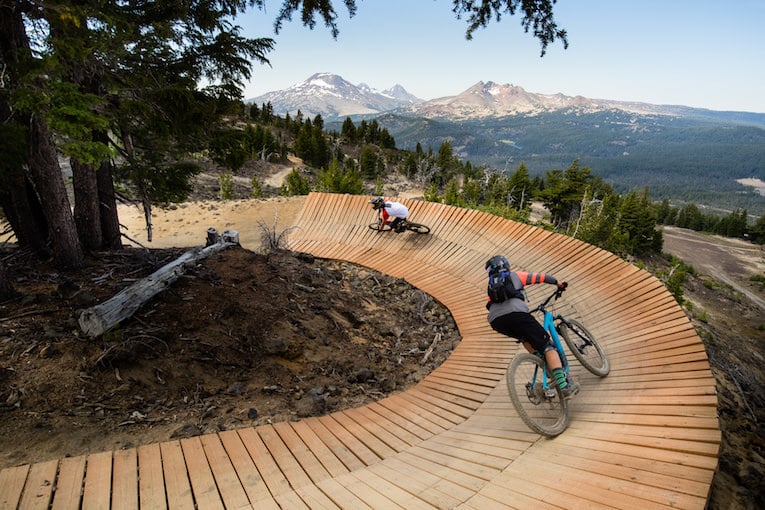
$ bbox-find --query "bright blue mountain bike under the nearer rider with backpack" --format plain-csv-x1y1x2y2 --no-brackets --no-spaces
507,289,611,437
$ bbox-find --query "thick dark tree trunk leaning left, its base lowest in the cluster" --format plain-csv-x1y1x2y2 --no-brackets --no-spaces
29,116,85,269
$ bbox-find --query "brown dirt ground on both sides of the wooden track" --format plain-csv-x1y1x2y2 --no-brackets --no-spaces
0,165,765,509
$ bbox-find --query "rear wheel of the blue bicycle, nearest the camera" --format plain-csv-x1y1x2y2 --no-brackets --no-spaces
507,352,569,437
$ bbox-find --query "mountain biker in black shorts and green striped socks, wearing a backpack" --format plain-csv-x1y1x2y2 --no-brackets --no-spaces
485,255,579,398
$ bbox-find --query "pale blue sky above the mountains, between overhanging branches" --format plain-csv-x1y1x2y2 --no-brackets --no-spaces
236,0,765,113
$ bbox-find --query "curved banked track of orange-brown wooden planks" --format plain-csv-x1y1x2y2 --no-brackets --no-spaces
0,193,720,510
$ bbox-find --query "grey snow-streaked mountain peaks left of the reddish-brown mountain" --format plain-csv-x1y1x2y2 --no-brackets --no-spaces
247,73,422,120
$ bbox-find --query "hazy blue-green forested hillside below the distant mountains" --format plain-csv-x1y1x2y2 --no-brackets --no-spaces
362,111,765,216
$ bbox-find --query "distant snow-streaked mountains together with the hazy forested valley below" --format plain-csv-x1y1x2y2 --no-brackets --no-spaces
248,73,765,216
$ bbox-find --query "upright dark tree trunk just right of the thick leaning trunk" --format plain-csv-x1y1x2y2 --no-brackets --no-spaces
71,158,102,251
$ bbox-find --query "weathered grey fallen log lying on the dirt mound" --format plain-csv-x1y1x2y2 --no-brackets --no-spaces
78,229,239,338
